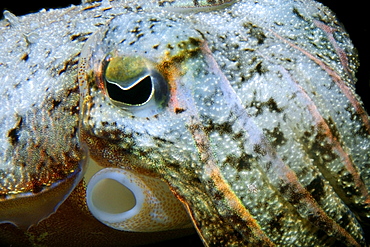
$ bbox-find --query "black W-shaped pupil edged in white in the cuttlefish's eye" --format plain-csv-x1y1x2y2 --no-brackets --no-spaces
106,76,152,105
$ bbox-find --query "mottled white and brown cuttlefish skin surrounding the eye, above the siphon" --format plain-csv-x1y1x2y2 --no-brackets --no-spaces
0,0,370,246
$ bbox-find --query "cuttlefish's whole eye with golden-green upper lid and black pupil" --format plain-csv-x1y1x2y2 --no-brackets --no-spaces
103,55,169,116
